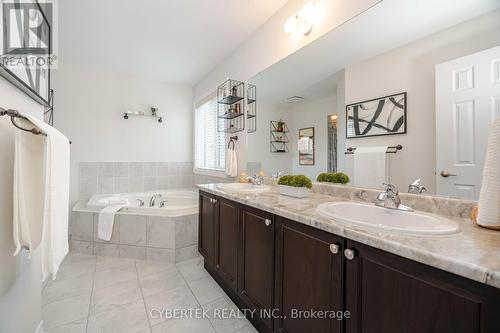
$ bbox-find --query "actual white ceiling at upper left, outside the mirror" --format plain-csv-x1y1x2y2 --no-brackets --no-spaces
58,0,287,84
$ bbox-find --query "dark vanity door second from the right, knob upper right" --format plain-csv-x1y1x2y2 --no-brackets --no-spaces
275,217,344,333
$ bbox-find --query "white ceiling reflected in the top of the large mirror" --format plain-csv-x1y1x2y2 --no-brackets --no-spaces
250,0,500,106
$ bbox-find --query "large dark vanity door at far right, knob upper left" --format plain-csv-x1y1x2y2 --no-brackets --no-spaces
346,241,500,333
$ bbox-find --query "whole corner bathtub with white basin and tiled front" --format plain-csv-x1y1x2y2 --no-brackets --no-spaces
70,189,199,263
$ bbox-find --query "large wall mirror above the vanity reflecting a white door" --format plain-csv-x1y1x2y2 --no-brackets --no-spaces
247,5,500,199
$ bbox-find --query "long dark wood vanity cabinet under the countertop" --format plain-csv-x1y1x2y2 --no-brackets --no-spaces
198,192,500,333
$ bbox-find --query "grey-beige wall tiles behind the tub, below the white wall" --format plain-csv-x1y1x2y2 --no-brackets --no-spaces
79,162,231,200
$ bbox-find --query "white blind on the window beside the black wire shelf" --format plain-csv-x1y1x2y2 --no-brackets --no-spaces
195,93,226,171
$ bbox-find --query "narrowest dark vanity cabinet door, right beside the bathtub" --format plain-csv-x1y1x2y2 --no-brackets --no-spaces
198,192,216,264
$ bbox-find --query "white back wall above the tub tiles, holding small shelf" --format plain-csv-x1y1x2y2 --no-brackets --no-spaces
53,63,193,203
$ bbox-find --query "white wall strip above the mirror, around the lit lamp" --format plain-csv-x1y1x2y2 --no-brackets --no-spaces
193,0,379,171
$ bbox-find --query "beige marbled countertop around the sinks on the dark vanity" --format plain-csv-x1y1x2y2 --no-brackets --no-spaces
198,184,500,288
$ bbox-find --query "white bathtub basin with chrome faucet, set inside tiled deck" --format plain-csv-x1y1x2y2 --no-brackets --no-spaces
87,190,198,216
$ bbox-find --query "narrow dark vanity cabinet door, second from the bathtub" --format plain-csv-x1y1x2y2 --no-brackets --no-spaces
215,198,239,290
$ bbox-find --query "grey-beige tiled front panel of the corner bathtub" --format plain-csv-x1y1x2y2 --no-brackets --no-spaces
70,210,198,263
